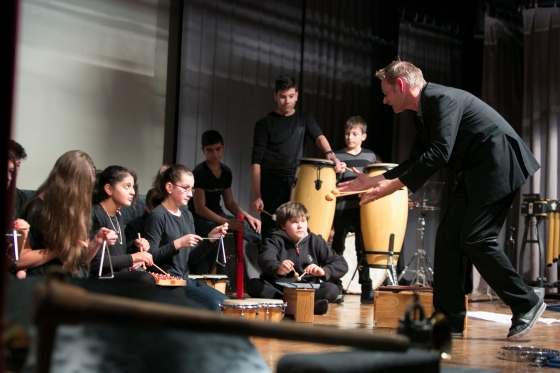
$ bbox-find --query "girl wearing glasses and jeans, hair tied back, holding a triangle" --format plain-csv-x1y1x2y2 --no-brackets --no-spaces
145,164,229,311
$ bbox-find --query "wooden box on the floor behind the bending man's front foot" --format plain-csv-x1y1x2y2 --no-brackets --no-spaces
373,291,468,330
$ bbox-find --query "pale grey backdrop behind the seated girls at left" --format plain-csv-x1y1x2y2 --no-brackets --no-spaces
12,0,170,193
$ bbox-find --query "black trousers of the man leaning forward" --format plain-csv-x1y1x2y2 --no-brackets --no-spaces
434,181,539,330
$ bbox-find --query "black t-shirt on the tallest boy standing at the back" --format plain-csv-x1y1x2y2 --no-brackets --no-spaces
251,111,322,177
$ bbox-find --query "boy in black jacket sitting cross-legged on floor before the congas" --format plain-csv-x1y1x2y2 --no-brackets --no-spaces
245,202,348,315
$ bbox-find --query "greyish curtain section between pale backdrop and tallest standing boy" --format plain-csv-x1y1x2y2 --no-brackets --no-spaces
177,0,302,211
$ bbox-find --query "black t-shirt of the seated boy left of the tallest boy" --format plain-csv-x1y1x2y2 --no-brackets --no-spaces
189,162,233,217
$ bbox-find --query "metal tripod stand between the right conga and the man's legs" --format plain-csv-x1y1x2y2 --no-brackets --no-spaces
398,199,434,286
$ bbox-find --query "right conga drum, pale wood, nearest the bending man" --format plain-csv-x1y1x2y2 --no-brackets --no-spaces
360,163,408,289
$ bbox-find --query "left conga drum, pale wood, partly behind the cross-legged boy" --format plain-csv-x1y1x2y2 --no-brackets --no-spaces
290,158,336,241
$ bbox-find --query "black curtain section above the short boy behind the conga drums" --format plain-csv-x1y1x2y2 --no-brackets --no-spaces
300,0,394,157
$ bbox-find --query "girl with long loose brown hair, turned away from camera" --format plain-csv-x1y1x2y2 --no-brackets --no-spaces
16,150,117,277
